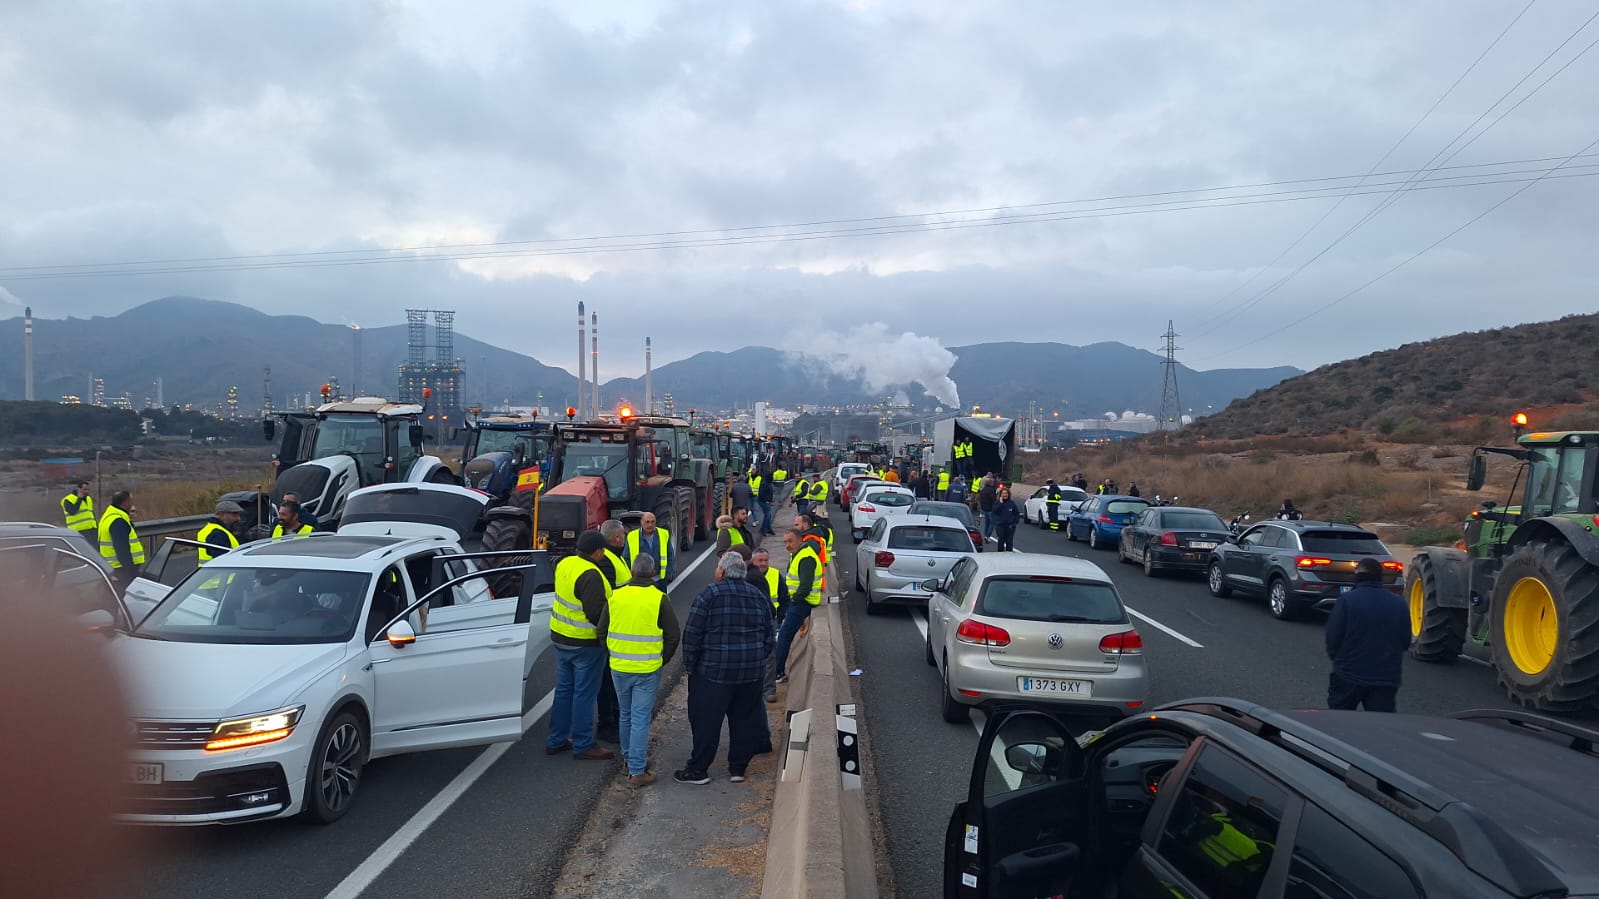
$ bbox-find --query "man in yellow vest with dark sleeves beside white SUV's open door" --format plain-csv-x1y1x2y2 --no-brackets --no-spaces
544,531,616,761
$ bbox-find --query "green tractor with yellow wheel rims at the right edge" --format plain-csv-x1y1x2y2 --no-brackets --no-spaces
1406,414,1599,712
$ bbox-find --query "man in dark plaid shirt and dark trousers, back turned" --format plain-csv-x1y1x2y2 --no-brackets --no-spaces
673,552,772,784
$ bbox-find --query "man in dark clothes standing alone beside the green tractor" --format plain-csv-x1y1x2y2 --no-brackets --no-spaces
1327,558,1410,712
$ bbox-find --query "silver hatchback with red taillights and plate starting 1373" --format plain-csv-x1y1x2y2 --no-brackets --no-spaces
927,552,1150,721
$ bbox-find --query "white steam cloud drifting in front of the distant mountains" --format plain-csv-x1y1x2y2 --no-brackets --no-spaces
795,322,961,408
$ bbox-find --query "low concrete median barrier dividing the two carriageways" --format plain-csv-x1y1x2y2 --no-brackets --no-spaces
761,569,878,899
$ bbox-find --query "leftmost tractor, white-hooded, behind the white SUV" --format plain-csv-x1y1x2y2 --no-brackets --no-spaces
261,387,456,528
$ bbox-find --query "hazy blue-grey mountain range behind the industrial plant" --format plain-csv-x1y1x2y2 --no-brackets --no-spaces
0,298,1300,419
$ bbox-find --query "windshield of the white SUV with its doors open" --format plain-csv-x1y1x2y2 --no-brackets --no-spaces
134,566,371,645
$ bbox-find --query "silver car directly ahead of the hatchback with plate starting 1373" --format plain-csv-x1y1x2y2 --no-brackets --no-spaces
855,515,974,614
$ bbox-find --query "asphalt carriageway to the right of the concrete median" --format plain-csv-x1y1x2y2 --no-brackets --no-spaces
833,507,1579,896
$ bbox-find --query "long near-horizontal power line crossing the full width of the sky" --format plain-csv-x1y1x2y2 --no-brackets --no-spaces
9,163,1599,282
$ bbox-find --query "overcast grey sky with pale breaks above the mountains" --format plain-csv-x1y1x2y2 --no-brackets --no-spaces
0,0,1599,378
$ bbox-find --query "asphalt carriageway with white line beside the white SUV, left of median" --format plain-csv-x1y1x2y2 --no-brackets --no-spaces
118,541,716,899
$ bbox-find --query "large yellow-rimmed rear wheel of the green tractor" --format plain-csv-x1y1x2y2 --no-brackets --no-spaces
1490,541,1599,712
